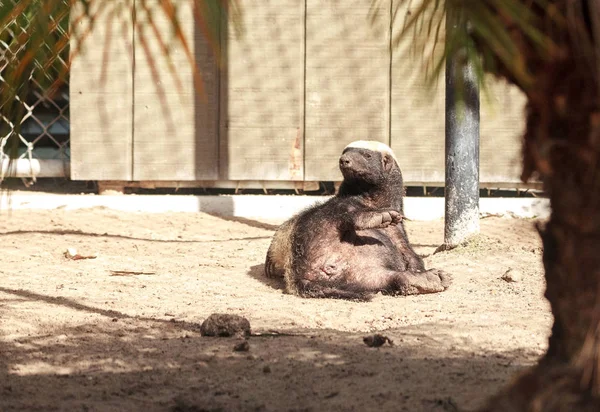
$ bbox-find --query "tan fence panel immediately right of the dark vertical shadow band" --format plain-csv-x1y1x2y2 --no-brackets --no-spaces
220,0,305,180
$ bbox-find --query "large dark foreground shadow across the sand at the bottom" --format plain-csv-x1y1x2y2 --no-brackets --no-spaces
0,289,531,412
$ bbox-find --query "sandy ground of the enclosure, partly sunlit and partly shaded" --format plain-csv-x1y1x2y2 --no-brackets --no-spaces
0,209,551,411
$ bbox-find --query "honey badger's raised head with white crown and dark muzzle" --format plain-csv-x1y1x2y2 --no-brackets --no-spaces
340,140,402,185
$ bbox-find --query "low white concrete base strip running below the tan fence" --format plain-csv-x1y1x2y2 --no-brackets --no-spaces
0,192,550,220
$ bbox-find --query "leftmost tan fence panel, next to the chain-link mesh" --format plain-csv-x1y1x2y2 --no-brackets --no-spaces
70,2,133,180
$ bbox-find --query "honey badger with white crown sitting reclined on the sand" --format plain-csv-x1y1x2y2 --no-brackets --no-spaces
265,140,451,300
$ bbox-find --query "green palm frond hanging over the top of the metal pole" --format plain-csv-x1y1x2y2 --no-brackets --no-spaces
372,0,566,101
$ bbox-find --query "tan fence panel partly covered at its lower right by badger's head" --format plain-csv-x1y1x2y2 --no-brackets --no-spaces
305,0,391,180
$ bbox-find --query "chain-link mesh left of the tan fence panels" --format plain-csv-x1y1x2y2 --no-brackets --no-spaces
0,0,70,180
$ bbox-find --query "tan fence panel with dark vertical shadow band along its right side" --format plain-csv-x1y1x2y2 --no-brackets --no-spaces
133,0,219,181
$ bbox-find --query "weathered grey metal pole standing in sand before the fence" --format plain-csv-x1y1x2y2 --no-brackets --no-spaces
443,18,479,249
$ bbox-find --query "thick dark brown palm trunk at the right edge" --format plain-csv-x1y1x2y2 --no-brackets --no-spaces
482,0,600,412
